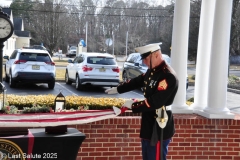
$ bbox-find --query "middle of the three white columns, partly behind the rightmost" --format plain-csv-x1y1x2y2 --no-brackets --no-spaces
191,0,216,112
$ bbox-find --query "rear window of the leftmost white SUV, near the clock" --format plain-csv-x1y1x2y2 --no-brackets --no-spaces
19,52,51,62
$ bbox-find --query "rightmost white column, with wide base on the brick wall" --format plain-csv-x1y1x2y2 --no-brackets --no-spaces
200,0,234,119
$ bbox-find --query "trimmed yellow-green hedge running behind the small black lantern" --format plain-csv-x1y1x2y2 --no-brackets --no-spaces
7,94,124,112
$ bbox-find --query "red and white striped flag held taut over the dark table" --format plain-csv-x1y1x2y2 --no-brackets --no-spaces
0,107,125,127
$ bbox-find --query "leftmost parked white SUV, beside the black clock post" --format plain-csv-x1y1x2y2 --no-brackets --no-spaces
4,49,56,89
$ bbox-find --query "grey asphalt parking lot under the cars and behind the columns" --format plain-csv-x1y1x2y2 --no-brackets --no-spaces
3,82,240,114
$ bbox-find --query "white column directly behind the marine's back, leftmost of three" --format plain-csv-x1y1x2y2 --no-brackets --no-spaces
171,0,192,113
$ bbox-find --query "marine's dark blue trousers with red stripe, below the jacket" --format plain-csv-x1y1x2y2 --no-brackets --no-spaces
142,139,171,160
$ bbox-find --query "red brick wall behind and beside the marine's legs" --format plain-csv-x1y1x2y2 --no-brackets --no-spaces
74,114,240,160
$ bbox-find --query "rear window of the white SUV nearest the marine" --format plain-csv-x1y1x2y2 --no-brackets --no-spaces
87,57,116,65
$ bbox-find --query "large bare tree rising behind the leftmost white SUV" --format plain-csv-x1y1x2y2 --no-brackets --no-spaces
24,1,71,53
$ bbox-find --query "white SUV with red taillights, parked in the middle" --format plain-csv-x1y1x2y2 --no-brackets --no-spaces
65,52,120,90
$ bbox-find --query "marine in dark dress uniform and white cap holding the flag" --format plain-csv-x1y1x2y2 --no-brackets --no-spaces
106,43,178,160
